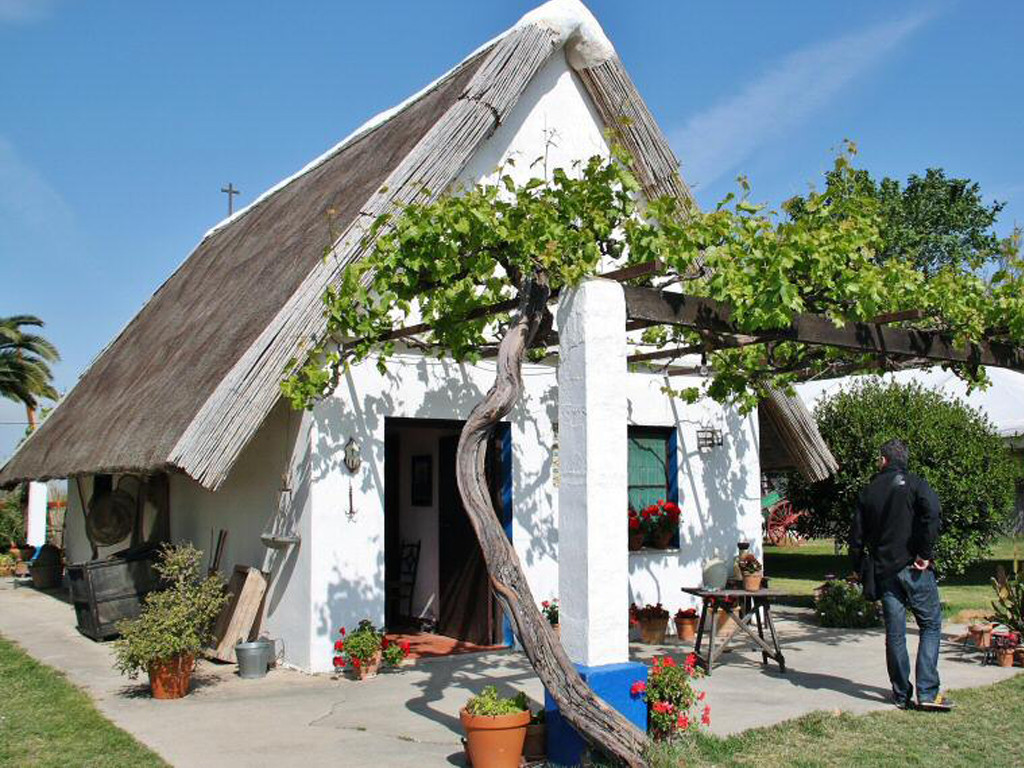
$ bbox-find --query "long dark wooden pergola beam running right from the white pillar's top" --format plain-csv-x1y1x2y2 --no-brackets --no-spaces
624,286,1024,371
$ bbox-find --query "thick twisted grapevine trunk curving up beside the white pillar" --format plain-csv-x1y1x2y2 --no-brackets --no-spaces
456,280,647,768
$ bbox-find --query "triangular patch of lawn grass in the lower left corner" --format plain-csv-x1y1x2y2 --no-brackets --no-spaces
0,638,167,768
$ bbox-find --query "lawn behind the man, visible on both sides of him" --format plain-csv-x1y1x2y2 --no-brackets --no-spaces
765,539,1024,617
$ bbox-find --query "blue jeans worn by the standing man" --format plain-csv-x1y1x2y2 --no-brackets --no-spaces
881,565,942,702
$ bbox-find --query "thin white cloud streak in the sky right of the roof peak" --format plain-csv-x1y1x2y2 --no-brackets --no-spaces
672,12,934,186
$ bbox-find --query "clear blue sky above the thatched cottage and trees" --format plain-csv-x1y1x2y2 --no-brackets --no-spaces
0,0,1024,459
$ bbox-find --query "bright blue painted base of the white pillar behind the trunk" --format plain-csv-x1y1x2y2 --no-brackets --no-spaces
544,662,647,766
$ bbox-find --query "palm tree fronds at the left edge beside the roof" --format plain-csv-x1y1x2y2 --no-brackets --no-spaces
0,314,60,431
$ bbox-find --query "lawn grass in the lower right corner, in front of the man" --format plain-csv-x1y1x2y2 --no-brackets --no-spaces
651,675,1024,768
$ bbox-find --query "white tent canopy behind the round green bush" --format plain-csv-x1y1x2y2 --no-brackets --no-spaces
797,368,1024,439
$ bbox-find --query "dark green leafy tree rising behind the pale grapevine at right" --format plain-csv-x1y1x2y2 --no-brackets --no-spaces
785,168,1006,274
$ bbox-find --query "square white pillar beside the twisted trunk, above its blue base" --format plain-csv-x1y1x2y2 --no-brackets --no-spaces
558,280,629,667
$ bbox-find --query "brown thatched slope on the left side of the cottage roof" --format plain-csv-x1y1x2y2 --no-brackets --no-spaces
0,40,486,484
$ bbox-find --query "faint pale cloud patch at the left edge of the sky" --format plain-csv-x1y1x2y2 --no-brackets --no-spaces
0,136,74,237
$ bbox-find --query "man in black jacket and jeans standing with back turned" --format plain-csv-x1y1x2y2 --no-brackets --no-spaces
850,440,949,710
